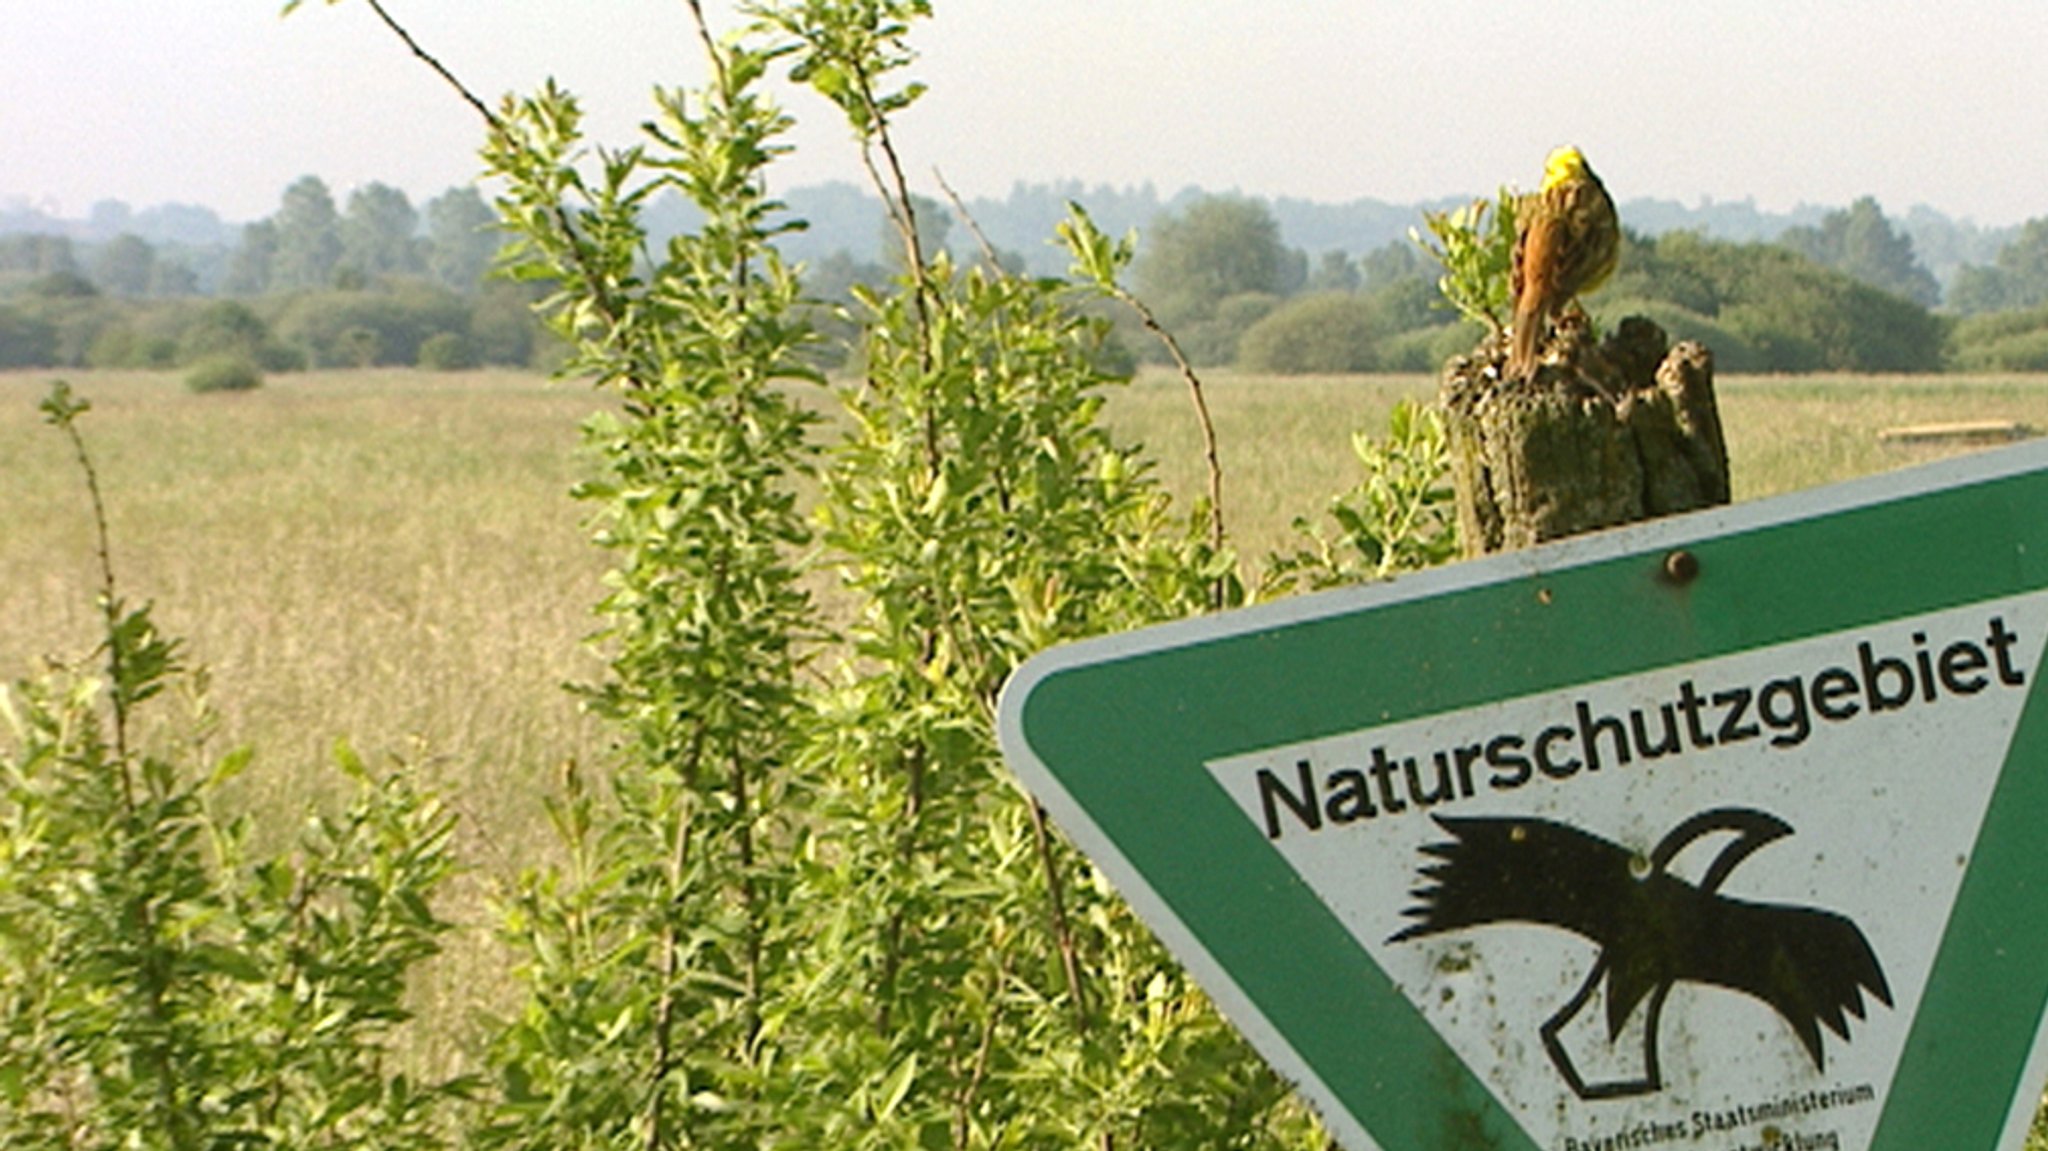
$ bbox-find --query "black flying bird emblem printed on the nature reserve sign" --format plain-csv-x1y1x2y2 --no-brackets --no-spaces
1386,807,1892,1100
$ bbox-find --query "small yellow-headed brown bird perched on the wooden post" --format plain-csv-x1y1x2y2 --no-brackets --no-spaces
1507,145,1622,379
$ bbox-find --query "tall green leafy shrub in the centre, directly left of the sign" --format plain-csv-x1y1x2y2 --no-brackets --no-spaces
452,0,1313,1147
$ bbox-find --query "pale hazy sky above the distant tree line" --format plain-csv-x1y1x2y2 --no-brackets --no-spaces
12,0,2048,223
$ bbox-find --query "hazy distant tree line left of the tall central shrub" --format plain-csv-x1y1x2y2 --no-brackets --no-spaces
0,176,551,371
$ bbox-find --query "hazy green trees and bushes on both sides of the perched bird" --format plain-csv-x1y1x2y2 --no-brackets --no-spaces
1089,197,2048,373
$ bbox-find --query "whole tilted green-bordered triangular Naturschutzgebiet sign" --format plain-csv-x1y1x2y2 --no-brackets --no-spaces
1001,444,2048,1151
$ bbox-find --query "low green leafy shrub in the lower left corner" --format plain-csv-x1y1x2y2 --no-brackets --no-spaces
0,383,467,1151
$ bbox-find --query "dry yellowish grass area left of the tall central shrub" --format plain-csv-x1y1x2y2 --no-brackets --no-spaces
0,373,602,862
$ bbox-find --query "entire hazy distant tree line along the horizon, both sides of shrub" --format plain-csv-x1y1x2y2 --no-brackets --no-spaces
12,176,2048,373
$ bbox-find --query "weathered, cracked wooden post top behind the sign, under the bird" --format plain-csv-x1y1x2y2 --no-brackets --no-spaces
1442,313,1729,557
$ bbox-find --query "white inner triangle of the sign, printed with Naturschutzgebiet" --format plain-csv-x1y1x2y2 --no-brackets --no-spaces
1210,594,2048,1151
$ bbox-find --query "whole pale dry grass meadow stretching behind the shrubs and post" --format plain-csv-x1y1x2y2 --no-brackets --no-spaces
0,360,2048,1081
